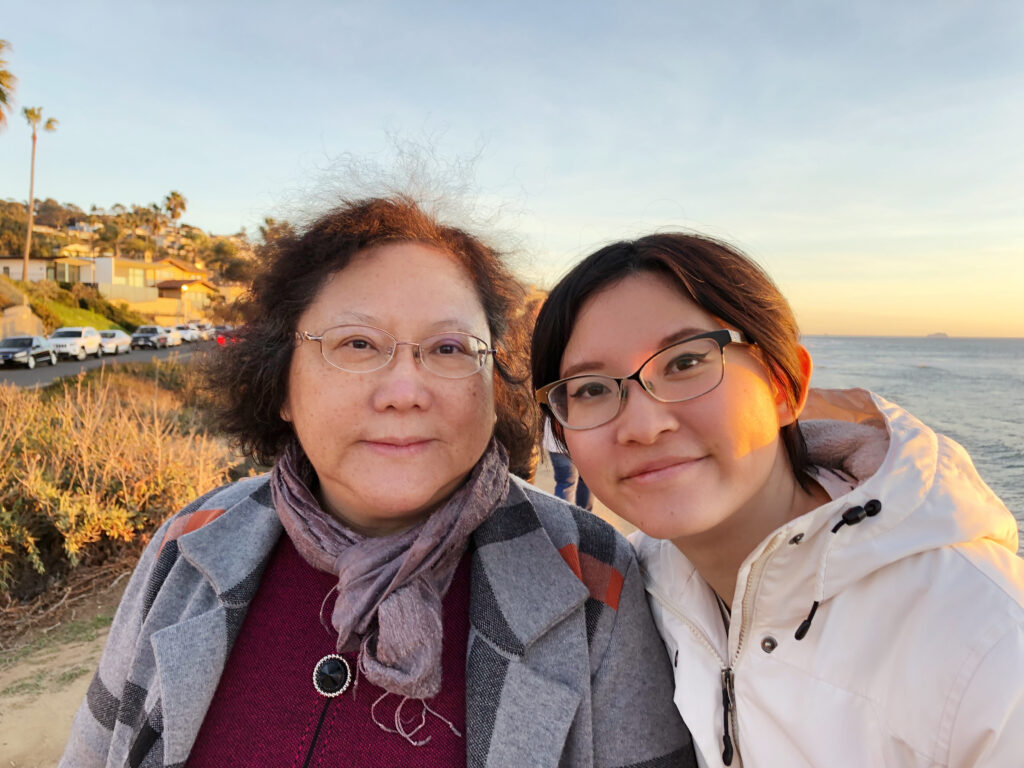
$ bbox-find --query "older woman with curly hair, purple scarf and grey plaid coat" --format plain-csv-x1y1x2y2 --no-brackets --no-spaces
61,199,694,766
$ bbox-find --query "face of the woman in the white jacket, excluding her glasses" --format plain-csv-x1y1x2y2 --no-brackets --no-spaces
560,273,794,544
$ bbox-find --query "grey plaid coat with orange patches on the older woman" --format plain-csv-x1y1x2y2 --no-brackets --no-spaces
60,475,696,768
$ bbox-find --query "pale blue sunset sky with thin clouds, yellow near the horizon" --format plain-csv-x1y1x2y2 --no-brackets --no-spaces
0,0,1024,337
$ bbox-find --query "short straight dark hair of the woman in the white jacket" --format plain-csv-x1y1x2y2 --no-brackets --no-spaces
531,232,809,486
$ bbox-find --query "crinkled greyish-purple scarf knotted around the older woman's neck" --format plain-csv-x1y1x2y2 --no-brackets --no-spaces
270,439,509,698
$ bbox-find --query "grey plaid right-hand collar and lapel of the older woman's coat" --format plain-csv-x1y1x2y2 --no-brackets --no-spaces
466,482,590,765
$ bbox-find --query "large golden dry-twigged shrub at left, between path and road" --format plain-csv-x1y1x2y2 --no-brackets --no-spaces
0,364,237,599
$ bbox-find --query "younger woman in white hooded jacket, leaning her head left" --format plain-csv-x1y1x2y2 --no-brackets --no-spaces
532,233,1024,768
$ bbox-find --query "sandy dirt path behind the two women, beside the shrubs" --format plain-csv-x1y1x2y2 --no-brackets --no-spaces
0,463,633,768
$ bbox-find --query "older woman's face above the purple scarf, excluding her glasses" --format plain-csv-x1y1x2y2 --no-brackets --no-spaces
281,243,496,535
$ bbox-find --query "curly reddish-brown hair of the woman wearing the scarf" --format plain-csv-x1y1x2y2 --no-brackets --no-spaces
204,196,540,475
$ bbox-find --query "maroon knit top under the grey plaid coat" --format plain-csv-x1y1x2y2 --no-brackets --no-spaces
187,536,470,768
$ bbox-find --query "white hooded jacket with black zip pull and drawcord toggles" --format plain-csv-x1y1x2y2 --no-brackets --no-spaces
632,390,1024,768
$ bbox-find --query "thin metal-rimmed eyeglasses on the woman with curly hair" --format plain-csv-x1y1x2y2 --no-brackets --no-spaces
295,326,496,379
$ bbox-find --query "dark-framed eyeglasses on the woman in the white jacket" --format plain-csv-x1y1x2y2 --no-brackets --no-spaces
537,328,746,429
